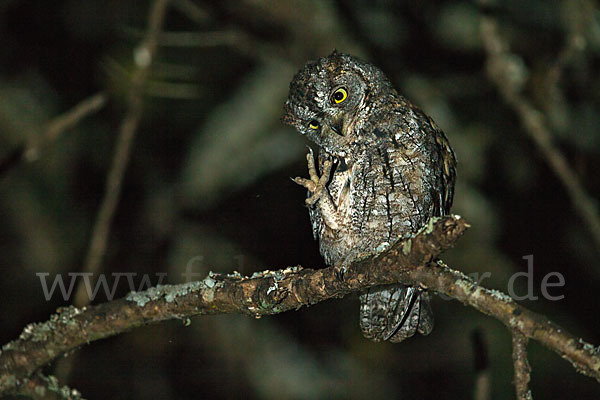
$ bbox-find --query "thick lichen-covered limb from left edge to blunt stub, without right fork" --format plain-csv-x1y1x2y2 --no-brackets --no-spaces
0,216,468,394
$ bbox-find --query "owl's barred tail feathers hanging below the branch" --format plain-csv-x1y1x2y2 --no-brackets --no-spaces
360,284,433,343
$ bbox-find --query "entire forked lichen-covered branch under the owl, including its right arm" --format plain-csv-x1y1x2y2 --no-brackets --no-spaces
0,216,600,394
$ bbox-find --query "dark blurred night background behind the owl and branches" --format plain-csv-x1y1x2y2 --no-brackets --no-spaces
0,0,600,399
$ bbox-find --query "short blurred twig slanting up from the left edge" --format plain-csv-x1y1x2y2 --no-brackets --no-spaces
0,92,106,176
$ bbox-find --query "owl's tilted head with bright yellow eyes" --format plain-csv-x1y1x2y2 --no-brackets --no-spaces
282,51,389,157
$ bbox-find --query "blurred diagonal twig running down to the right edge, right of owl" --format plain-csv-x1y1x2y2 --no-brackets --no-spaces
480,16,600,253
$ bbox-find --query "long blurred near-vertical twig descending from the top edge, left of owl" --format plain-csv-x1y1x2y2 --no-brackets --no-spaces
74,0,168,306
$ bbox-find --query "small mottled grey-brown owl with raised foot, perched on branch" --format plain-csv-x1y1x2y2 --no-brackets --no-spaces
283,51,456,342
